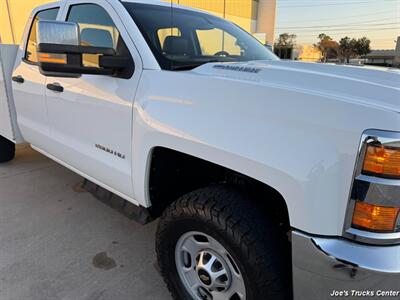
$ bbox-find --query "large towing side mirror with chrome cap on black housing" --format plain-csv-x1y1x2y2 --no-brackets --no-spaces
37,21,134,78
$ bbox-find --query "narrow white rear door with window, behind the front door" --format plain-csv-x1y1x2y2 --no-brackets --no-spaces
12,6,60,149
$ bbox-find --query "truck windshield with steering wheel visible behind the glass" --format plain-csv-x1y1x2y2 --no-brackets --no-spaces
124,2,278,70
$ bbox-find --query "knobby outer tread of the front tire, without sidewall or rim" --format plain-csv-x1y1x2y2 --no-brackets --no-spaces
156,185,291,299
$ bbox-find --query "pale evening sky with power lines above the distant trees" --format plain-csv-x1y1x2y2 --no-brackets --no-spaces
276,0,400,49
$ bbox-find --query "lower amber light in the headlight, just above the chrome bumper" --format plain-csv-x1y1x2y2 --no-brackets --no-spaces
352,201,400,232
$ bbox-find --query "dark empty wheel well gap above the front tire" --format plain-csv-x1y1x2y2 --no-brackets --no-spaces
148,147,290,230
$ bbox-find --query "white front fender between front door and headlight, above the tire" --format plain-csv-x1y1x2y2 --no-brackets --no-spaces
133,70,398,235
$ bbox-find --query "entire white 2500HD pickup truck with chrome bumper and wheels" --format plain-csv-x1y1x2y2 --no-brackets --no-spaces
0,0,400,300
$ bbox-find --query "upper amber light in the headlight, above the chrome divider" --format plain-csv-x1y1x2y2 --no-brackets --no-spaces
363,145,400,179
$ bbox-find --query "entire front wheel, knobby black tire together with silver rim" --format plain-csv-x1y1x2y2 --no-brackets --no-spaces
156,185,291,300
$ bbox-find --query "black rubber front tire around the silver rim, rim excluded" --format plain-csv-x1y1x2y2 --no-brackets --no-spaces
156,185,292,300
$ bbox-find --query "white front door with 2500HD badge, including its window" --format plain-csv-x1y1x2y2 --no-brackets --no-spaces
46,0,141,198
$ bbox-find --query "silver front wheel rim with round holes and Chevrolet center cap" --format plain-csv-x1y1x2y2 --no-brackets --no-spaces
175,231,246,300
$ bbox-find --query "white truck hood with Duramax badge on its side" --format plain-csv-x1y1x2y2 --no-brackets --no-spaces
191,61,400,113
